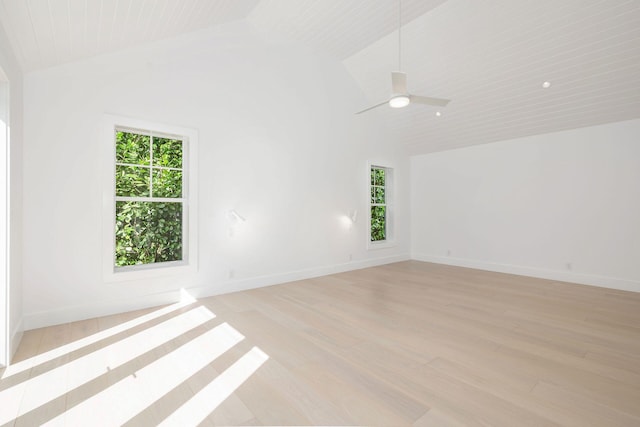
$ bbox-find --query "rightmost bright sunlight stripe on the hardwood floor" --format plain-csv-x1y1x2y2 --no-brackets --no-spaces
160,347,269,427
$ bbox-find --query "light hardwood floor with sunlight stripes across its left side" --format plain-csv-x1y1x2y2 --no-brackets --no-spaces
0,261,640,427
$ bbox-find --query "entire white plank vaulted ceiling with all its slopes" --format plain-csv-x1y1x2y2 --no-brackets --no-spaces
0,0,640,153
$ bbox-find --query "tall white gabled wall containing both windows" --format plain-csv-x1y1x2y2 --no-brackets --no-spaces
24,22,409,328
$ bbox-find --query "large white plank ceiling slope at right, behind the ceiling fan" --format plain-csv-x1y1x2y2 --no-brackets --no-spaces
344,0,640,154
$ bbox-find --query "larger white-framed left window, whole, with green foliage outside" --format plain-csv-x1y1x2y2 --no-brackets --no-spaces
101,114,198,282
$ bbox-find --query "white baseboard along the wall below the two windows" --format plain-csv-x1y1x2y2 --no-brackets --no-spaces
23,254,410,332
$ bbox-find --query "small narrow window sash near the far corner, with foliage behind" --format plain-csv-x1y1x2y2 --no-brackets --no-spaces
369,165,391,243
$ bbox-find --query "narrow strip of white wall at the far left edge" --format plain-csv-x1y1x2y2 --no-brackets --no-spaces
0,22,23,363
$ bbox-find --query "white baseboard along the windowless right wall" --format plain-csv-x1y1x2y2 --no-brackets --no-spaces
411,254,640,292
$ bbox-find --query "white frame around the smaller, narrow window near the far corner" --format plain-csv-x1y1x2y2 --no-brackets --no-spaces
367,162,396,250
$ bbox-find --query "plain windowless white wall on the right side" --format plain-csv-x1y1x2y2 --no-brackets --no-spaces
411,120,640,292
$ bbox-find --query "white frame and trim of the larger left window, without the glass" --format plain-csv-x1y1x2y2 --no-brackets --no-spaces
102,115,198,282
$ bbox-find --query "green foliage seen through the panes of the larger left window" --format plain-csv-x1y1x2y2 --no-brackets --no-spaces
115,131,183,267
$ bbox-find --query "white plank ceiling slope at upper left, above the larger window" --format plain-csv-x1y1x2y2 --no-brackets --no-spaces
0,0,258,71
